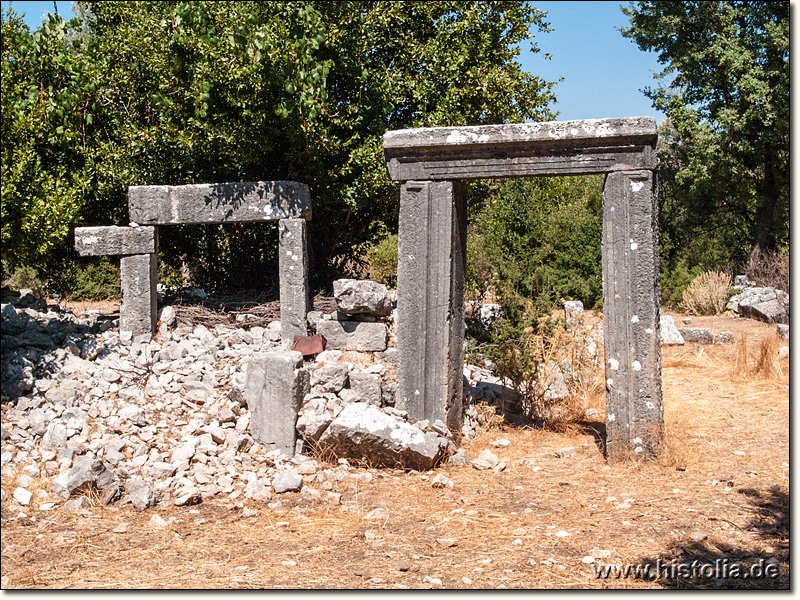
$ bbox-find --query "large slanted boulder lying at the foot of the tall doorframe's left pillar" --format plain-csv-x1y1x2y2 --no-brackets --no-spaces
320,402,447,470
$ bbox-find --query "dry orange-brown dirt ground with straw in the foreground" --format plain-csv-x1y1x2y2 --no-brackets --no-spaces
2,315,789,589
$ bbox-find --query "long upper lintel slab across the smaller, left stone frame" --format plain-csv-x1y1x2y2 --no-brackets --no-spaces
128,181,311,225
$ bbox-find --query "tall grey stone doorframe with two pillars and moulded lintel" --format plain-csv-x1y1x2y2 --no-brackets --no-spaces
383,117,663,457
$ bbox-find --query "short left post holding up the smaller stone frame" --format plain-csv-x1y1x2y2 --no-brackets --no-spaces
119,254,158,336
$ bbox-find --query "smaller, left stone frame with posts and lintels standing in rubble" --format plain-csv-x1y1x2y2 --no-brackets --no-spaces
75,181,311,347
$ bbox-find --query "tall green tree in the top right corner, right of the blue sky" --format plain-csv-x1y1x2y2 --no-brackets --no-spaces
622,1,789,260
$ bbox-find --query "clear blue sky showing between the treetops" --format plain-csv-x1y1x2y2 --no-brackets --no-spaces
2,0,664,122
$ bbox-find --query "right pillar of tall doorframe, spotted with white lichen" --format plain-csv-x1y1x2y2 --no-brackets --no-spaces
603,170,664,458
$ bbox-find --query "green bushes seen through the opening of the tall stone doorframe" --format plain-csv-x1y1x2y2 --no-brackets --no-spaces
467,177,603,324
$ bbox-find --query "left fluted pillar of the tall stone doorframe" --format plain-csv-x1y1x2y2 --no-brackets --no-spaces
397,181,467,433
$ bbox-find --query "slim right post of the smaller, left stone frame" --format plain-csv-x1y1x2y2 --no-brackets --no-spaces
278,219,311,349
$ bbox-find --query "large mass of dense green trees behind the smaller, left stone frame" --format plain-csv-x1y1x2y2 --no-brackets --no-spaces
2,1,552,287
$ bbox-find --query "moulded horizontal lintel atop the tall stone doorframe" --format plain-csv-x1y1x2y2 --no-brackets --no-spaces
383,117,658,181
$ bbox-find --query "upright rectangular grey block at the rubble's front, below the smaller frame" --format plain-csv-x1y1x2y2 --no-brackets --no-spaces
244,351,310,456
